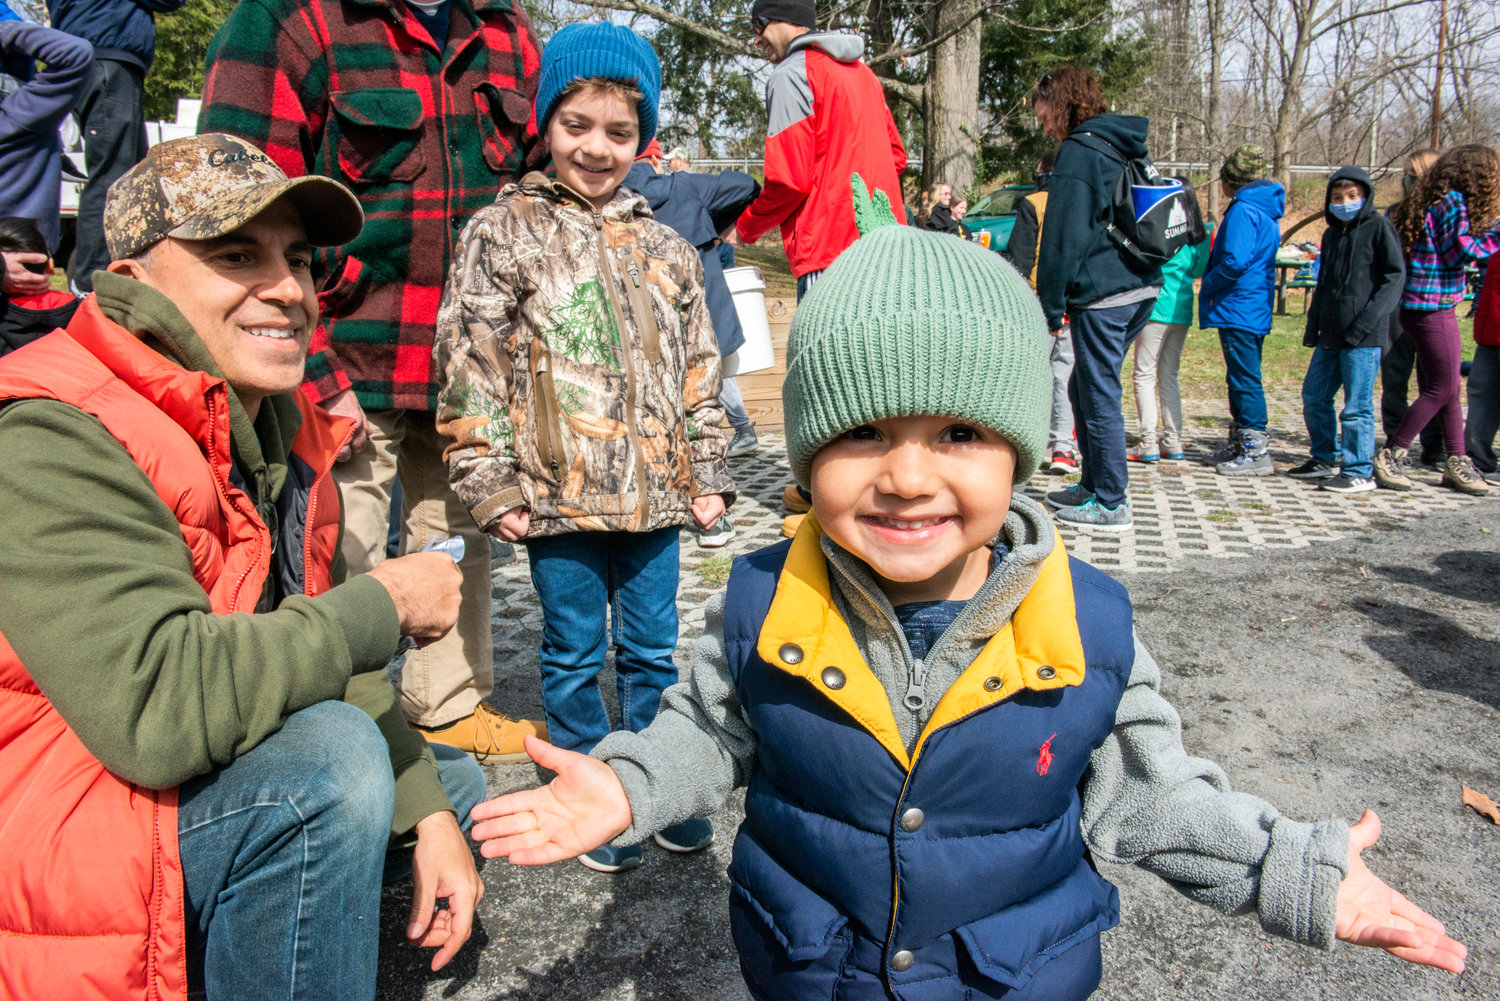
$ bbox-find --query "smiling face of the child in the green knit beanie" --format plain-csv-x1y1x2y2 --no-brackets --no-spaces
812,416,1016,605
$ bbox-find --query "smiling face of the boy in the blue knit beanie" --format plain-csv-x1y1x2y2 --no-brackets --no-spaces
548,87,641,209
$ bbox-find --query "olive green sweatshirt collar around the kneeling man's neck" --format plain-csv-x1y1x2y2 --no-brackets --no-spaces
95,272,302,513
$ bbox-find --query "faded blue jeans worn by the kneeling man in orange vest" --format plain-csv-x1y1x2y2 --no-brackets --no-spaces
177,702,485,1001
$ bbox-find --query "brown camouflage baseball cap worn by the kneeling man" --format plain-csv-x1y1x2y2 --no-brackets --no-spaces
104,132,365,261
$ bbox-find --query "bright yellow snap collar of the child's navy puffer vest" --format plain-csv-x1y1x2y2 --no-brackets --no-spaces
756,504,1085,768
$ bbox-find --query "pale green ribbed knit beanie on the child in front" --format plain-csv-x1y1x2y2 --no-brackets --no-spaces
782,176,1052,486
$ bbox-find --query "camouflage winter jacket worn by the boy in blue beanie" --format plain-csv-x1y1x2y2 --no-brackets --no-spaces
435,173,734,537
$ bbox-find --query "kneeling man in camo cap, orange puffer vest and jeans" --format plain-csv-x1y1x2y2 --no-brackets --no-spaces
0,134,485,999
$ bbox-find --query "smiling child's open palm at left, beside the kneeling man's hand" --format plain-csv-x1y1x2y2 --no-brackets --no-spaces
470,734,630,866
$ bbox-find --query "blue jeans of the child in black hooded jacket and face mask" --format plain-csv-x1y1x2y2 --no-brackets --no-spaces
1302,345,1380,479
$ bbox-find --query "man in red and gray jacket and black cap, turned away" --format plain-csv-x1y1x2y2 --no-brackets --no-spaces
737,0,906,299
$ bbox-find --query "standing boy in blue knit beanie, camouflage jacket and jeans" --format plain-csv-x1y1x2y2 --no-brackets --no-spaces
435,23,735,872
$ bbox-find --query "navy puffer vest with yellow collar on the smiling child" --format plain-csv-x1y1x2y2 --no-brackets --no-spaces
725,519,1134,1001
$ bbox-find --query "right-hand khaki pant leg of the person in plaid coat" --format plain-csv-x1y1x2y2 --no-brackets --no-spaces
399,411,495,726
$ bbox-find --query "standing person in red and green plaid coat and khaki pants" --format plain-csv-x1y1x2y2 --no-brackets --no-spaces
198,0,545,761
